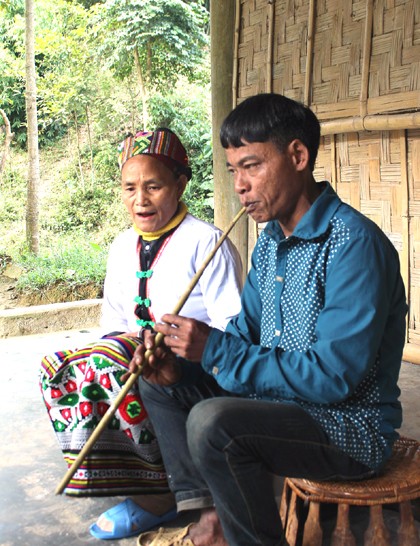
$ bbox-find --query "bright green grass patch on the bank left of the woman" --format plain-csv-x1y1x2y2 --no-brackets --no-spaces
16,241,107,293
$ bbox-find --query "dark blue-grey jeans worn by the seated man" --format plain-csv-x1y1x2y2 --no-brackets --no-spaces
139,364,372,546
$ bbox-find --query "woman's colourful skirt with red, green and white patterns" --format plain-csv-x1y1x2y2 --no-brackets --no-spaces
40,335,168,496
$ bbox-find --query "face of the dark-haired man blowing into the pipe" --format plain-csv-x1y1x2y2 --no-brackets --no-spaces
226,141,303,225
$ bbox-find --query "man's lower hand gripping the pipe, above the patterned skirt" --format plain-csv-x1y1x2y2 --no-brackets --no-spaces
121,330,181,386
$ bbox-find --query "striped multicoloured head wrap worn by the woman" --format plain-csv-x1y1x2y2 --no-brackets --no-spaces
118,128,191,180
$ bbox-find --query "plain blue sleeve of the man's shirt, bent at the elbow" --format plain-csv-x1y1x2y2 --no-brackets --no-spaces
202,232,407,403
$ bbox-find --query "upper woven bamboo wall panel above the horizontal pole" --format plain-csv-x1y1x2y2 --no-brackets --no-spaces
238,0,420,120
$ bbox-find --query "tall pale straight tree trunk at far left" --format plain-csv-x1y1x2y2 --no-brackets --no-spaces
25,0,40,254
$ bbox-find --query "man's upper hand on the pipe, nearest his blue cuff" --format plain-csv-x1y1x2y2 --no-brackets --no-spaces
155,314,211,362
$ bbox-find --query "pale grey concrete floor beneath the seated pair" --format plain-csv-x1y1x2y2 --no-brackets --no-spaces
0,329,420,546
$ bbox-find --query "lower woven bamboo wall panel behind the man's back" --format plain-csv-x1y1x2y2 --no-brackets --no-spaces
314,130,420,361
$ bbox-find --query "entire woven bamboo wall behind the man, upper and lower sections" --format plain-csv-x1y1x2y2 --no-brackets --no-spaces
234,0,420,364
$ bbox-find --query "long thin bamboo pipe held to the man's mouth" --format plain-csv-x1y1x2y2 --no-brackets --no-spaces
55,204,246,495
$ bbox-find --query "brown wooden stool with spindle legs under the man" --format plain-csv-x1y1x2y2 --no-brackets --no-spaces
280,438,420,546
